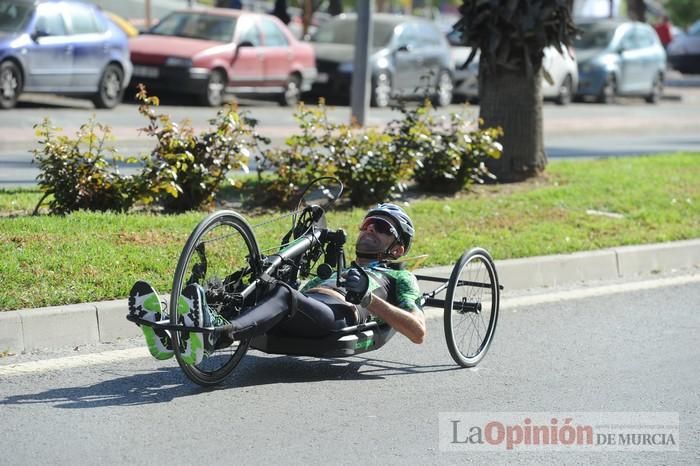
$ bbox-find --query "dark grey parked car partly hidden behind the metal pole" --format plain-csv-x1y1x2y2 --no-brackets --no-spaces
311,13,454,107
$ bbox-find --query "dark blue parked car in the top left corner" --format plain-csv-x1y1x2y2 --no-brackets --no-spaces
0,0,131,109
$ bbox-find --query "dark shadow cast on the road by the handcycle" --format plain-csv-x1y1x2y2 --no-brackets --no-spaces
0,355,459,409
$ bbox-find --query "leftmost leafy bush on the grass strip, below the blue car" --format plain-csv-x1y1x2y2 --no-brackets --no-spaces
32,116,136,215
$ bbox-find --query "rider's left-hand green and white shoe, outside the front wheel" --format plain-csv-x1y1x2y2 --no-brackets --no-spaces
129,280,175,360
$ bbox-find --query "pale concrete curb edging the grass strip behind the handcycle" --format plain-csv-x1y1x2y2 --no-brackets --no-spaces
0,239,700,353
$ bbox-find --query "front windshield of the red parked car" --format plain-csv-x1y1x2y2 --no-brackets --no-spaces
148,12,236,42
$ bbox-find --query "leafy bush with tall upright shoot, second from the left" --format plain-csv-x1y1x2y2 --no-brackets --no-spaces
137,86,269,212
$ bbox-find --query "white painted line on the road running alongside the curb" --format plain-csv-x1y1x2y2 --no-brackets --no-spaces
0,274,700,377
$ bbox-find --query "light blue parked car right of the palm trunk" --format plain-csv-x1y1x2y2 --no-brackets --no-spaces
574,20,666,103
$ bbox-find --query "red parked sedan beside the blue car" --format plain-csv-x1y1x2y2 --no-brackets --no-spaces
129,8,316,107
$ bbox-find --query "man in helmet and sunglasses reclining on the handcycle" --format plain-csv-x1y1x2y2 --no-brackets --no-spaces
129,204,425,364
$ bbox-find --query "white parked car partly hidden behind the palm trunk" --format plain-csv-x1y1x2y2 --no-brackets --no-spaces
447,30,578,105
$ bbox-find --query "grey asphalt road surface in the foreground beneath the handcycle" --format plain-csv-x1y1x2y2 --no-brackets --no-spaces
0,276,700,465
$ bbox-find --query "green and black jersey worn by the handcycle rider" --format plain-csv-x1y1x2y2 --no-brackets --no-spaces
301,263,423,312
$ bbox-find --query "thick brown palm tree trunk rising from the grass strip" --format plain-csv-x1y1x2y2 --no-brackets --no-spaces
479,62,547,182
